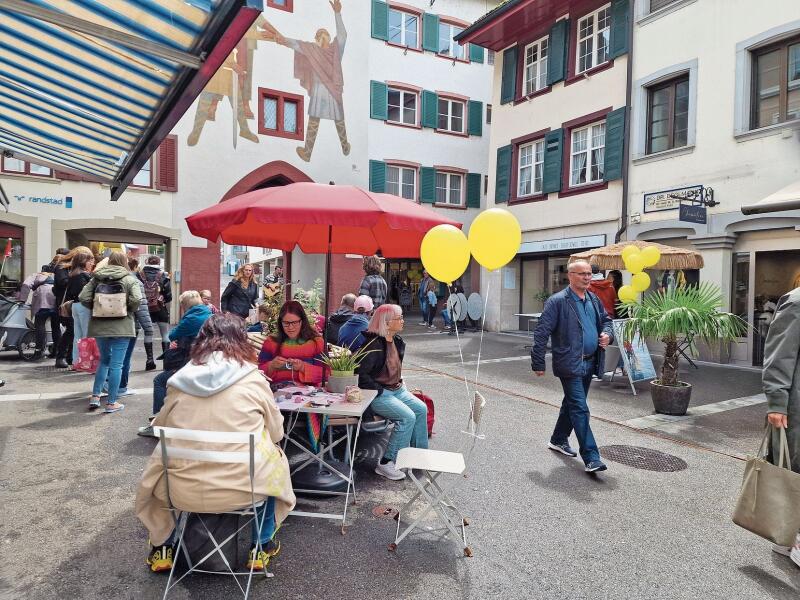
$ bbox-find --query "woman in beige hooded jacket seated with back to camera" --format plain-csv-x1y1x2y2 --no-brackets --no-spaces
135,313,295,571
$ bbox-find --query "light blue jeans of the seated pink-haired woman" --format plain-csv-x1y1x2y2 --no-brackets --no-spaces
370,385,428,460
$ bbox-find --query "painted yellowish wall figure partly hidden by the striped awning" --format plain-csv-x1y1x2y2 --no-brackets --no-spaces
186,16,266,148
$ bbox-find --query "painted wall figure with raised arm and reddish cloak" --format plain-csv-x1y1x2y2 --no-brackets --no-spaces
261,0,350,162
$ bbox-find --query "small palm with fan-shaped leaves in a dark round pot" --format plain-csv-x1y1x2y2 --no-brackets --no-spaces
623,282,747,415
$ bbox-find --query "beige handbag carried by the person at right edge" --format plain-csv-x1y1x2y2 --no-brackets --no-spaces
733,425,800,546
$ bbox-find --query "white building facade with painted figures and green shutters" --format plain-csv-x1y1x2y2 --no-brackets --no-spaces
0,0,495,316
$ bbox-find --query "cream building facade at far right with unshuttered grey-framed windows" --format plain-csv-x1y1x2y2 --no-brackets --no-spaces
626,0,800,365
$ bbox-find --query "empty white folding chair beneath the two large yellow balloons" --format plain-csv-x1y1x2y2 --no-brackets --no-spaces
389,392,486,556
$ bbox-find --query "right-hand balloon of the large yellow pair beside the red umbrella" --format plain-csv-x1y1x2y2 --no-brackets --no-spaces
469,208,522,271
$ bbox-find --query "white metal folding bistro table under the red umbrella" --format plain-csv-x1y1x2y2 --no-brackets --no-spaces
275,388,376,533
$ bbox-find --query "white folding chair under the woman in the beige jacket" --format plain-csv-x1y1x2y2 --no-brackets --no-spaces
153,427,272,600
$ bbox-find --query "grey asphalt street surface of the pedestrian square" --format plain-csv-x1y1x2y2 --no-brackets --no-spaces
0,324,800,600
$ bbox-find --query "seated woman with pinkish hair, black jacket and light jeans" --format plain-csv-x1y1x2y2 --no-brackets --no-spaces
358,304,428,480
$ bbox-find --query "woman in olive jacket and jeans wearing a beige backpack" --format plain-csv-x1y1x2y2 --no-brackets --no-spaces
78,251,142,413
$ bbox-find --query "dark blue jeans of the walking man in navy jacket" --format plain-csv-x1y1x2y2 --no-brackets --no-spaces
550,360,600,464
